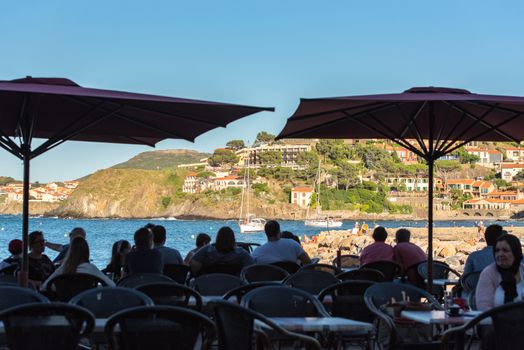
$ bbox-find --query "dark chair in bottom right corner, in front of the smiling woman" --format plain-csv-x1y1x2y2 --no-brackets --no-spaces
442,301,524,350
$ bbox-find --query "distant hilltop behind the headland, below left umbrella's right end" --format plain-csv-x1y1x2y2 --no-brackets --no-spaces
111,149,210,170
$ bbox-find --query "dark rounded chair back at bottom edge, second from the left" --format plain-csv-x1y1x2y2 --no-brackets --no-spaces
104,305,216,350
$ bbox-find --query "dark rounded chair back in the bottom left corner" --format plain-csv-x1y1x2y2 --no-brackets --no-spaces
0,302,95,350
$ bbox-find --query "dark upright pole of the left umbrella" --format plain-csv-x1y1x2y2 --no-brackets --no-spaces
18,144,31,287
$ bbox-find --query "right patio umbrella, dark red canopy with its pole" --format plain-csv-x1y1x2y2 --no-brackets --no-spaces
277,87,524,290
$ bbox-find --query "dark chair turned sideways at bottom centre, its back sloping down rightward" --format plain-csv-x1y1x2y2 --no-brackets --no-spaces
212,301,320,350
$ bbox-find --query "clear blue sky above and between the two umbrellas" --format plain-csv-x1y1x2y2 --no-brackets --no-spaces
0,0,524,182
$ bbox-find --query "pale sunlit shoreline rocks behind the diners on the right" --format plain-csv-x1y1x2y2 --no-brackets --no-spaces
302,227,524,273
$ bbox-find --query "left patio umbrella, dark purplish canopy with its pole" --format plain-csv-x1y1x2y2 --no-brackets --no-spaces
0,77,274,285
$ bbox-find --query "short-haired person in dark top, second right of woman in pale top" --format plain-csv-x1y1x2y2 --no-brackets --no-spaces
122,227,164,277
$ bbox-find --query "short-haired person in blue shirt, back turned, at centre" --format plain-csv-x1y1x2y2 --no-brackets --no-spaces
252,220,311,265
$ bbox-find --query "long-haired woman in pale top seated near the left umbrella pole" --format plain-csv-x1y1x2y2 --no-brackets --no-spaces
40,237,115,290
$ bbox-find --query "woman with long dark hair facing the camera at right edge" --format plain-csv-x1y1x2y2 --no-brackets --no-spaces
475,234,524,311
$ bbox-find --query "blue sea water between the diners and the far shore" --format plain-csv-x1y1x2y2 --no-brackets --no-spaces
0,215,524,268
